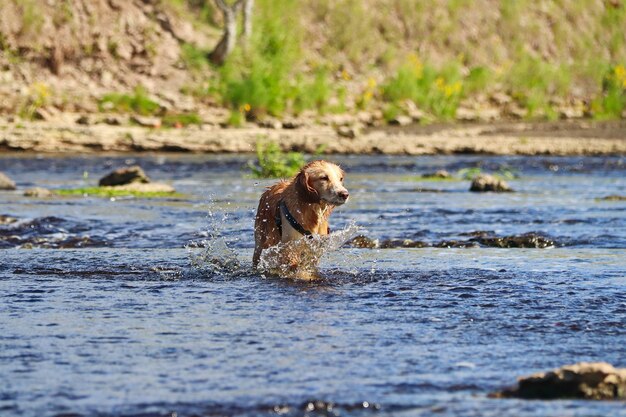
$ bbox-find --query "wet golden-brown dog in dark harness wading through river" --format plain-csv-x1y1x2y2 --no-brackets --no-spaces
252,161,350,268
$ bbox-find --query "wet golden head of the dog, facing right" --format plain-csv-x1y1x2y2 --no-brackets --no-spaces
295,161,350,206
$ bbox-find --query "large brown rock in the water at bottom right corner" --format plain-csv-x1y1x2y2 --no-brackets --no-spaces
491,362,626,400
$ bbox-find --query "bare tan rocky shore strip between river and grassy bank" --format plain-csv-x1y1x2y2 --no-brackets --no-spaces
0,119,626,155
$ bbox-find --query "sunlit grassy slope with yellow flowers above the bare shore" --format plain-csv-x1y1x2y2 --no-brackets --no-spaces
0,0,626,127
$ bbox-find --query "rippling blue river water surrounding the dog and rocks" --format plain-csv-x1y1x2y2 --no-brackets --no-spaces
0,156,626,416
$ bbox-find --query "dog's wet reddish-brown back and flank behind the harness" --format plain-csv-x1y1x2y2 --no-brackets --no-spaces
252,181,289,267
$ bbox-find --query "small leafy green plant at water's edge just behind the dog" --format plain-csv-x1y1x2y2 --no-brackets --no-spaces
248,141,306,178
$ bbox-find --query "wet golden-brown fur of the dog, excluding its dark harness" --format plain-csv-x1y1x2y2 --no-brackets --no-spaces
252,161,347,267
